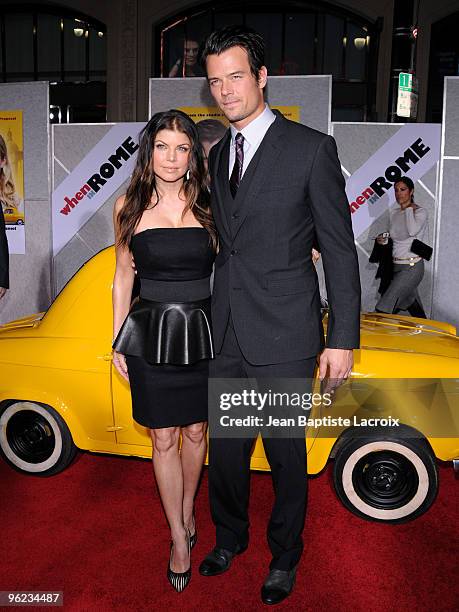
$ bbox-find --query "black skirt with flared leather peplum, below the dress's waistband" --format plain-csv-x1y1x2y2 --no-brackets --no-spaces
113,298,214,429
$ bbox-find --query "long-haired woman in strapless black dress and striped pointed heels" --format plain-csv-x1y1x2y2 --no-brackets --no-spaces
113,110,217,592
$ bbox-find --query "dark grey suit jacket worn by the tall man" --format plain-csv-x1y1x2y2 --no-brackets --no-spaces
209,111,360,365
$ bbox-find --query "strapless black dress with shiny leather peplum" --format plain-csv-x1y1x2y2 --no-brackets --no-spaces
113,227,215,429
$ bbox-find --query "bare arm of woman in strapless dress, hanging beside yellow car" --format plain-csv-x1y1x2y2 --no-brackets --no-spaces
112,196,135,380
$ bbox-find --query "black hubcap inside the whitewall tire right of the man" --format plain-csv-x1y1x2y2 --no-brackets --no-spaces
352,451,419,510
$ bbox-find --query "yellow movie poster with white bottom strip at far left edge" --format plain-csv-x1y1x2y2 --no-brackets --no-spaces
0,110,25,254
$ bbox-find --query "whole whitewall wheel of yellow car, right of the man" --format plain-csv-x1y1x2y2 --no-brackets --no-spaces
333,432,438,523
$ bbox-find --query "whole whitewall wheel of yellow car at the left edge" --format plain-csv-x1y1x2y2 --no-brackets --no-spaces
0,402,77,476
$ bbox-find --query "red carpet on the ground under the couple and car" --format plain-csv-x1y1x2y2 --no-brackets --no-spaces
0,453,459,612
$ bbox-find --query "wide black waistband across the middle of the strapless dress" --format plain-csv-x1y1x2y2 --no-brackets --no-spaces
140,276,210,302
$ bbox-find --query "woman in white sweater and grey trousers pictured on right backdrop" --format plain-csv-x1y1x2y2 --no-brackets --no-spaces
375,176,427,318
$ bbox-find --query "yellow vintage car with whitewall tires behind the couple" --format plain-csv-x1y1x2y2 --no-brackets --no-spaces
0,247,459,523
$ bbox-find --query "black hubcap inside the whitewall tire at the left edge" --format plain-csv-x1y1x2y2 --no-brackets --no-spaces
6,410,56,463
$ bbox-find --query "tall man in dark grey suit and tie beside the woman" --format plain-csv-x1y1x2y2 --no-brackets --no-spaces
200,26,360,604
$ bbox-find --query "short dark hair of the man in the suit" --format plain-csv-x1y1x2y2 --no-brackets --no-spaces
200,25,265,81
